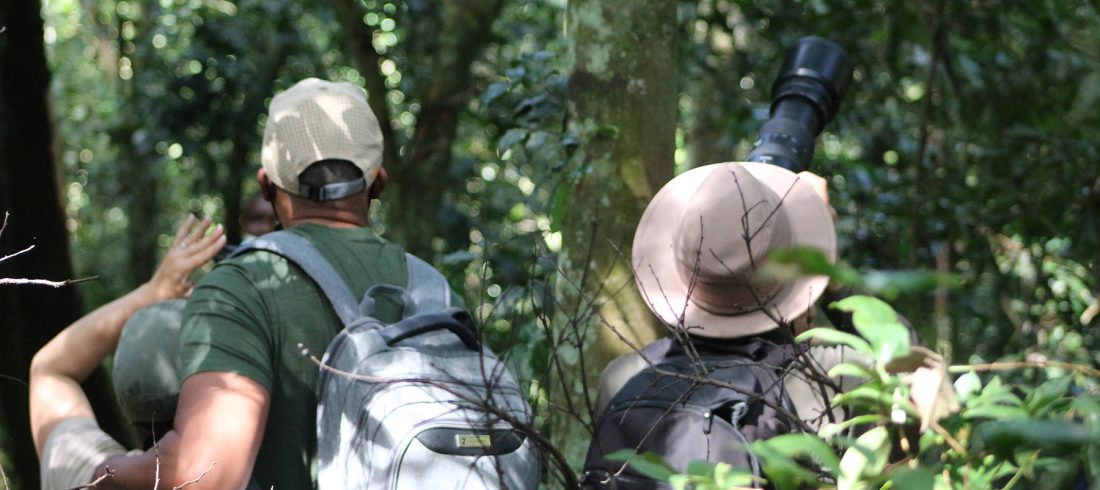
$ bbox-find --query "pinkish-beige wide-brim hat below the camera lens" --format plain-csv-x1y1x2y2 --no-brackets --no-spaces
633,162,836,338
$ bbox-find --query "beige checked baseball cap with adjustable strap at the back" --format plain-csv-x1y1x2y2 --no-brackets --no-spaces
261,78,382,200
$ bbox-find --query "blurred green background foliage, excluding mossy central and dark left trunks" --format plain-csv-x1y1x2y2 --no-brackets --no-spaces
0,0,1100,481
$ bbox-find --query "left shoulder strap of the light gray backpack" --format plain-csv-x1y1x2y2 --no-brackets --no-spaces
230,230,360,327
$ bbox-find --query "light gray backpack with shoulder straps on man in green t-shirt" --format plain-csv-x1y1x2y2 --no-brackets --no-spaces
238,231,540,490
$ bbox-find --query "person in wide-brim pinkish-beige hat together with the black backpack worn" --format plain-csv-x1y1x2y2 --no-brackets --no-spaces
583,163,871,489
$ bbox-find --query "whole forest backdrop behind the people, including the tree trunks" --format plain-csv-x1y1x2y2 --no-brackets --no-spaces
0,0,1100,488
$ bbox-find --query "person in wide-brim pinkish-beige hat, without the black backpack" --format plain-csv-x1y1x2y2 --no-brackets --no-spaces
596,162,856,427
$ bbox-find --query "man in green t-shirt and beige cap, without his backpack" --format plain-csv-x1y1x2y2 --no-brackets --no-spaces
91,78,442,489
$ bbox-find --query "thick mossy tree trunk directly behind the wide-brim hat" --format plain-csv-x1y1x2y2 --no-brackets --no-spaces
551,0,678,460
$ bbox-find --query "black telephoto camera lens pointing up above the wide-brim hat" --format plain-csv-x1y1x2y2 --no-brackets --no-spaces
746,36,851,172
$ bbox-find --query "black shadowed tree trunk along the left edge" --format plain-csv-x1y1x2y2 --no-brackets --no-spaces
0,0,125,488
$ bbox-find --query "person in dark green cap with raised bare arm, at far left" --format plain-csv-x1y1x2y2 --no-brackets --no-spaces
30,216,226,490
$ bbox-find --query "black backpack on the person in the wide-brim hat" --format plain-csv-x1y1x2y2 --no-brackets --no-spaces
582,336,801,490
